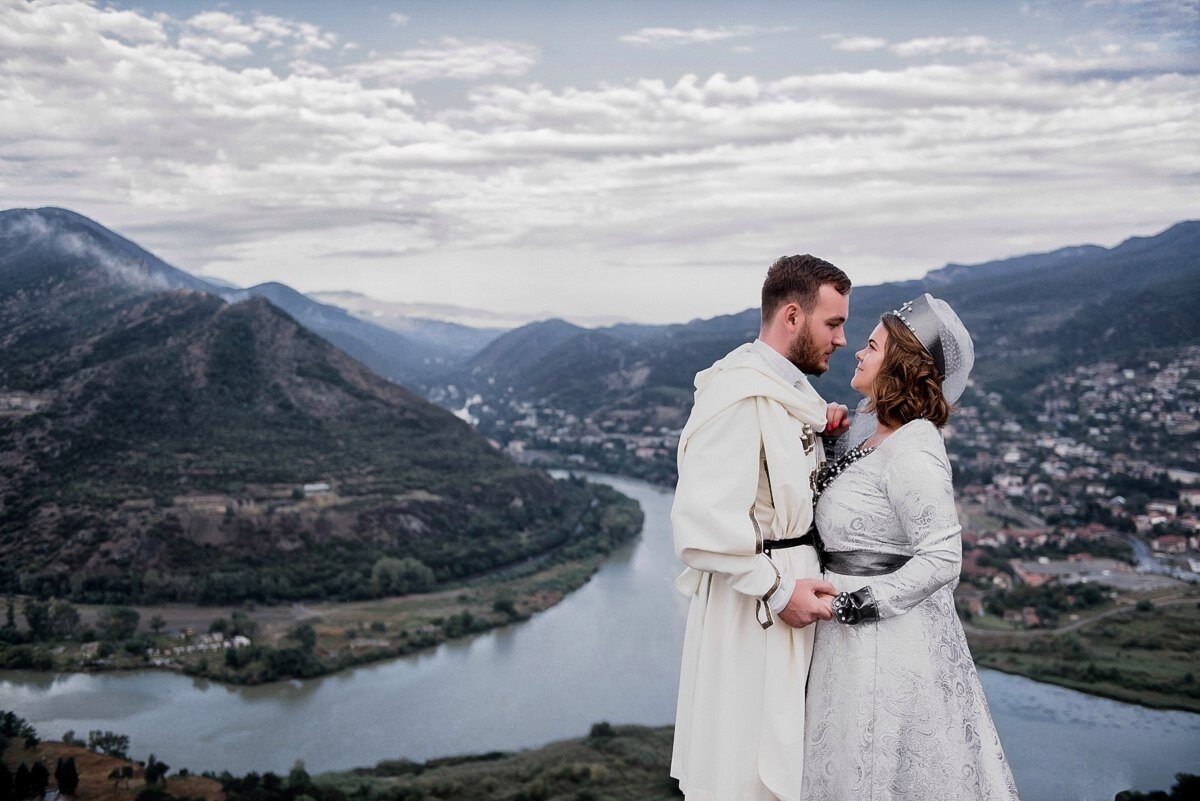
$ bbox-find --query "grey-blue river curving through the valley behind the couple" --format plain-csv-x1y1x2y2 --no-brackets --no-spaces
0,477,1200,801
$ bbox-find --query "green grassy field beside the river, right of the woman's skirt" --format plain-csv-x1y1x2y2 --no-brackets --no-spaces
971,601,1200,712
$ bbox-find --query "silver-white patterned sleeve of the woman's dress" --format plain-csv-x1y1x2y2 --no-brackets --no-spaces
868,432,962,620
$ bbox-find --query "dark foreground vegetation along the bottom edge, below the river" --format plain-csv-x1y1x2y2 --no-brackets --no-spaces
0,711,1200,801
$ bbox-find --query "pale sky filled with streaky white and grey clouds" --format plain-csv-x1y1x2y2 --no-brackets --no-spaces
0,0,1200,324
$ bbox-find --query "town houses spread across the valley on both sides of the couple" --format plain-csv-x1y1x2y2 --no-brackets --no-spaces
453,347,1200,613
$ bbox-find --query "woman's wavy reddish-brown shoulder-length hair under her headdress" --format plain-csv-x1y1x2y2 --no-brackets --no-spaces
871,314,954,428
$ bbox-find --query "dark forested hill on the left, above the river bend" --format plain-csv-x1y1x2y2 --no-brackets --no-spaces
0,212,637,602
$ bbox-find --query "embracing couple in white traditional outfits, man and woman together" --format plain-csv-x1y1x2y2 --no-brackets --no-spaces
671,255,1016,801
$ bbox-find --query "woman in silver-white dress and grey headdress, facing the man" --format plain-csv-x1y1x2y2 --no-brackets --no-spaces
802,295,1016,801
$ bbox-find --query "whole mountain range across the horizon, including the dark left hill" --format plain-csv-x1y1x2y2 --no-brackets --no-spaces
0,209,1200,600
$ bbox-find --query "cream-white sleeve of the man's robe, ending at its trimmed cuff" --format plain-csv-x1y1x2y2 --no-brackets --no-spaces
671,399,781,601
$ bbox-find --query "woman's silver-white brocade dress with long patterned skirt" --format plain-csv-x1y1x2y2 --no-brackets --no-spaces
802,420,1018,801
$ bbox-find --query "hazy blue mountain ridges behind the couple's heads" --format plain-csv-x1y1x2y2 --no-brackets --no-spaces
444,215,1200,426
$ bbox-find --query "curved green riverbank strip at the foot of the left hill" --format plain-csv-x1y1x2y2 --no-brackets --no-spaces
0,479,644,685
